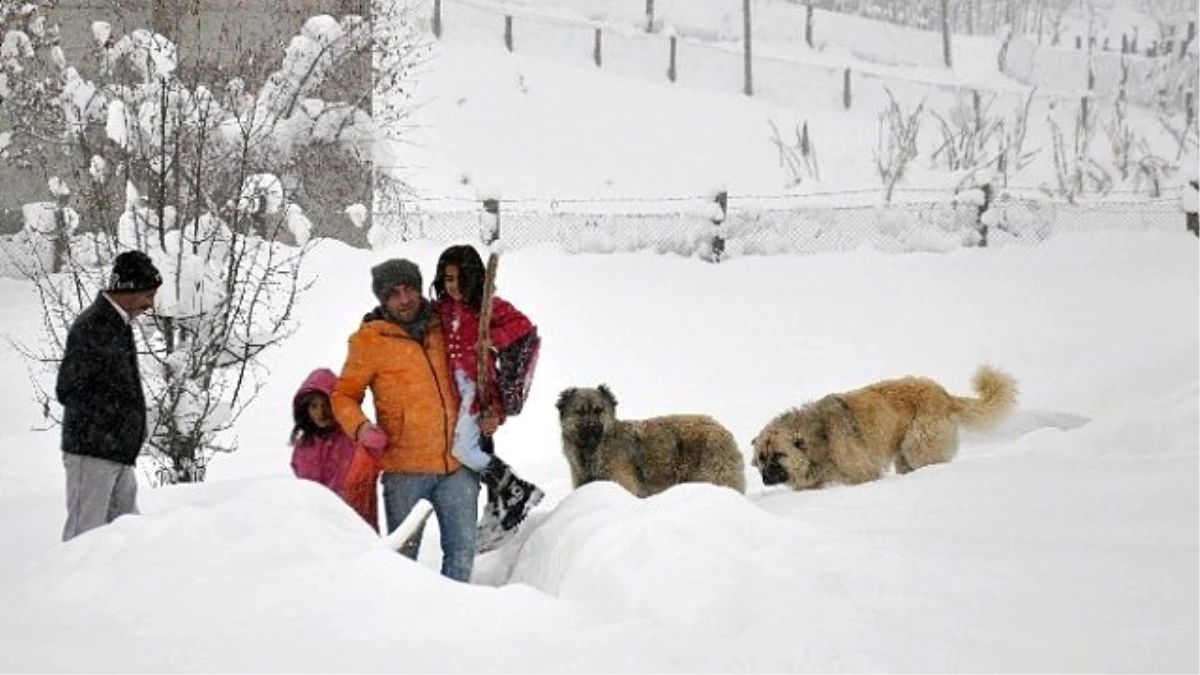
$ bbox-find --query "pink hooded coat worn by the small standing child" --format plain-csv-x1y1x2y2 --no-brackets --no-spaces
292,368,379,531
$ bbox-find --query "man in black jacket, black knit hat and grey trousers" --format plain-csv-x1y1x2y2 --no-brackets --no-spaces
55,251,162,542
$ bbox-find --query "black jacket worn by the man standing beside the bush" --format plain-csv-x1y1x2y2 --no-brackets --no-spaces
55,294,146,466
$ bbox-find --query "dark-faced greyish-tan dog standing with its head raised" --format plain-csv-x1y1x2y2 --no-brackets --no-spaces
557,384,745,497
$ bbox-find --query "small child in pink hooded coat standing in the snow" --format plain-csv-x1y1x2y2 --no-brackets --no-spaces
292,368,379,532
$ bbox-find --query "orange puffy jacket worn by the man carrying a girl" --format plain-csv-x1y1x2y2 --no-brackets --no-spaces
329,311,461,473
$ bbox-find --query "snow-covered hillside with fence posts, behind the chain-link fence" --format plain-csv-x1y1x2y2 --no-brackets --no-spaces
393,0,1187,208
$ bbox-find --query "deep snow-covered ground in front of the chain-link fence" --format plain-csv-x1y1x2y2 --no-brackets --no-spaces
0,232,1200,674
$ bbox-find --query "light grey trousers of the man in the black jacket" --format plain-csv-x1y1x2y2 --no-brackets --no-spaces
62,453,138,542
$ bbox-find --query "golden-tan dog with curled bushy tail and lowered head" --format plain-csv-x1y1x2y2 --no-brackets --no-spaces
751,366,1016,490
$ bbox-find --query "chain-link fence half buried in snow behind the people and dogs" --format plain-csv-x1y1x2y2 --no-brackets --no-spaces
372,196,1187,259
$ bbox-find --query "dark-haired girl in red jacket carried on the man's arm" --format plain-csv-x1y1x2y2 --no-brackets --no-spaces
433,246,544,551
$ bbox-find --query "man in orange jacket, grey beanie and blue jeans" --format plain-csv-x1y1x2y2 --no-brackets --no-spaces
330,258,479,581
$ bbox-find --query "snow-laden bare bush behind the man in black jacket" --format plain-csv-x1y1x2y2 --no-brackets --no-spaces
0,0,421,483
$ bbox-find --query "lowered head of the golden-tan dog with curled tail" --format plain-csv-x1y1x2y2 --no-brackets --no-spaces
750,408,829,490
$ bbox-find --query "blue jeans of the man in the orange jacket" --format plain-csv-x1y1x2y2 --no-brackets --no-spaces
382,467,479,581
